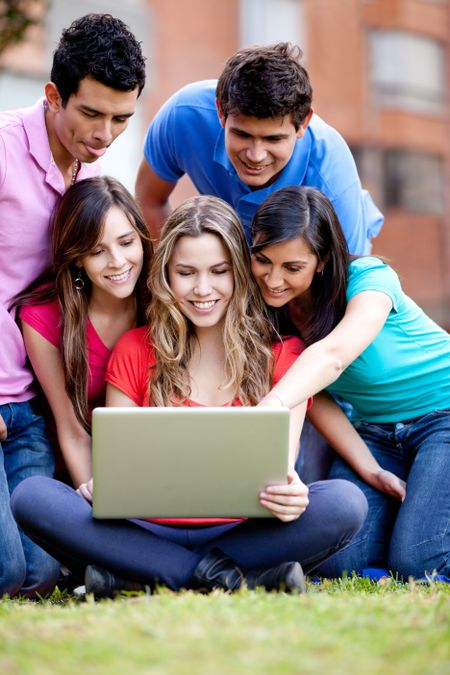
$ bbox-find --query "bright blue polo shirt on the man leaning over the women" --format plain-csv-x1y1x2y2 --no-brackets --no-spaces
144,80,383,255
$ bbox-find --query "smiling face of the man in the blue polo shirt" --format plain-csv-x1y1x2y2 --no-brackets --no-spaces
219,112,310,189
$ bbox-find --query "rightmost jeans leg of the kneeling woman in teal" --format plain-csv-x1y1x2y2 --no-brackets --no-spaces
389,411,450,579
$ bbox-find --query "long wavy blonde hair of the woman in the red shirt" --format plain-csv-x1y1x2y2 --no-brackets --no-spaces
147,196,273,406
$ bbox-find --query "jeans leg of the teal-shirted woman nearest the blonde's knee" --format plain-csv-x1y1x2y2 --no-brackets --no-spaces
316,424,407,577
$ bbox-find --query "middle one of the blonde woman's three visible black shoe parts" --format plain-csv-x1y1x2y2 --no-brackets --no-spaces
189,548,244,592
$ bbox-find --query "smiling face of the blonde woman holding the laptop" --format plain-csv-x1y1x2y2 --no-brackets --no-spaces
168,234,234,329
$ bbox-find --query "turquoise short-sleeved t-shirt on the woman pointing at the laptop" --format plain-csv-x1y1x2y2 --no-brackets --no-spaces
328,257,450,423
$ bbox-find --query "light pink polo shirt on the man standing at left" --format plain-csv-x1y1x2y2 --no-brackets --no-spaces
0,99,100,405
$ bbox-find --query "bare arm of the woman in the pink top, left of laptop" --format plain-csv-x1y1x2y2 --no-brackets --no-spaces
22,322,92,487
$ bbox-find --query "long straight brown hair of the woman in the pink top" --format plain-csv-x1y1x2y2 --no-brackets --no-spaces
18,176,153,432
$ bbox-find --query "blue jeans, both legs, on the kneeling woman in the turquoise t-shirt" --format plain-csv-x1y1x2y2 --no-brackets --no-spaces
317,410,450,579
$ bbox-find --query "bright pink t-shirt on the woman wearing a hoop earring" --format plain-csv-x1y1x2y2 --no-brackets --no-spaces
19,299,111,411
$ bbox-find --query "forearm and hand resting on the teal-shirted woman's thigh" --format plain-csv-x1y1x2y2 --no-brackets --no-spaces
308,392,406,501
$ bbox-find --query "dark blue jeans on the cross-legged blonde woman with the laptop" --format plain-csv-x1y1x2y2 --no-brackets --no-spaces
11,477,367,590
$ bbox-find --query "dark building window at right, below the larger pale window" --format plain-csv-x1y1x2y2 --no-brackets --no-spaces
383,150,444,216
